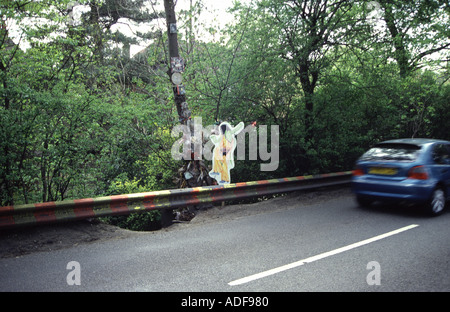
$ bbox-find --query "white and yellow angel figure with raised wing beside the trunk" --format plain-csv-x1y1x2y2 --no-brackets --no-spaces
209,122,244,185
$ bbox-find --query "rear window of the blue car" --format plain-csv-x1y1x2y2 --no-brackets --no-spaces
361,143,420,161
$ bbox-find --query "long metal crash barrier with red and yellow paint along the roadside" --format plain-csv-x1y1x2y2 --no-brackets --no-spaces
0,171,351,229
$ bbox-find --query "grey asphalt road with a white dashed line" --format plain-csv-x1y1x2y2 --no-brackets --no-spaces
0,189,450,292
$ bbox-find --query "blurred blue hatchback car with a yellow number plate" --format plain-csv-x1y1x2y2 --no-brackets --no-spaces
352,139,450,215
